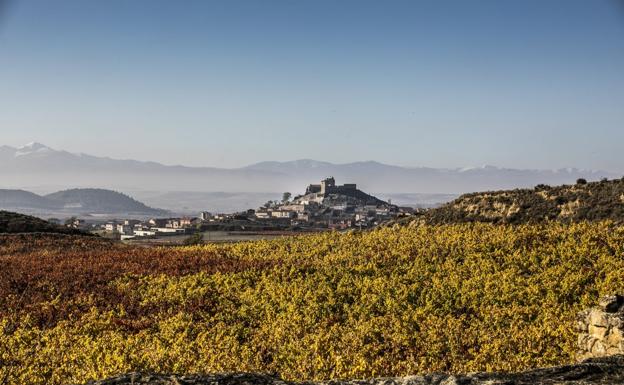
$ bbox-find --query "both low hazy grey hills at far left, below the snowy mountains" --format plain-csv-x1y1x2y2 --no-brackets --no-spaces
0,189,167,215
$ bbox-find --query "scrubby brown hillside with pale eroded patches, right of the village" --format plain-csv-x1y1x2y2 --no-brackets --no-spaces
419,178,624,224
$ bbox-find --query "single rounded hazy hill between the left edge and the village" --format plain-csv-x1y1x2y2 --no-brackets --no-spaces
45,188,163,215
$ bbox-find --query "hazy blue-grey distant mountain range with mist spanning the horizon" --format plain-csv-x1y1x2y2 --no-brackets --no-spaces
0,143,621,211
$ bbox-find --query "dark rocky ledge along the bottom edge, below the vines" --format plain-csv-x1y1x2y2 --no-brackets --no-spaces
83,356,624,385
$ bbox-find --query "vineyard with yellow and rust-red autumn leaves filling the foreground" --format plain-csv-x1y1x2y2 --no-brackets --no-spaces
0,222,624,384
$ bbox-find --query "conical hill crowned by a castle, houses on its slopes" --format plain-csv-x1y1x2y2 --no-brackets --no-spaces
255,177,413,229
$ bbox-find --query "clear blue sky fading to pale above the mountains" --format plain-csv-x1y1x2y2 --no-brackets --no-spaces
0,0,624,172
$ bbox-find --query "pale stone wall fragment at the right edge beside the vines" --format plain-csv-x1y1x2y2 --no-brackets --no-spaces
576,295,624,361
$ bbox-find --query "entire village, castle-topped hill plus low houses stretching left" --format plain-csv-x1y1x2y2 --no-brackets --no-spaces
77,177,414,239
